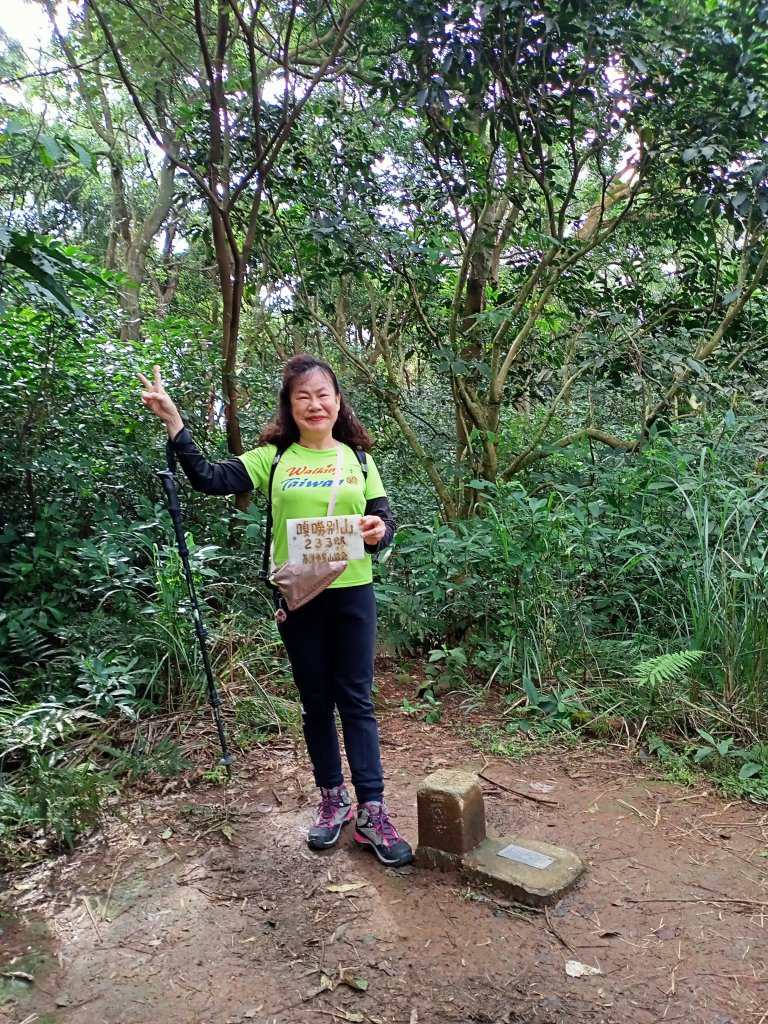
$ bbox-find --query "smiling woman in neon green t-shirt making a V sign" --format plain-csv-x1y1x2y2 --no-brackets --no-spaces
138,355,413,867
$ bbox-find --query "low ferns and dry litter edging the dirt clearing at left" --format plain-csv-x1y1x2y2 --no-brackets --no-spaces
0,634,300,866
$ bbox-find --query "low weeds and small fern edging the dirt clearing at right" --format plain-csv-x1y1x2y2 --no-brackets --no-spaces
394,651,768,815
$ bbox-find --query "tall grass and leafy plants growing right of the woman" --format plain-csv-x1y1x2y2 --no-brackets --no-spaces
378,442,768,736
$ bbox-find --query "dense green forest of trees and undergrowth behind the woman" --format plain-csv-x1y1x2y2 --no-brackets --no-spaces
0,0,768,851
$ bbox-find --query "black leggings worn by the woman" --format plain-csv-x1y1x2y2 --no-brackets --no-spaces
279,584,384,804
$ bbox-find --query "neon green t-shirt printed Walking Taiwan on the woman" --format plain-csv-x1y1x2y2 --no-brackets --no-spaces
239,444,386,587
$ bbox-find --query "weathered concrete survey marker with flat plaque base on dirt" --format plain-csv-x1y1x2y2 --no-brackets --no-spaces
416,769,584,906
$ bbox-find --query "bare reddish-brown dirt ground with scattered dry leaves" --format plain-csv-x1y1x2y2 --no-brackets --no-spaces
0,679,768,1024
